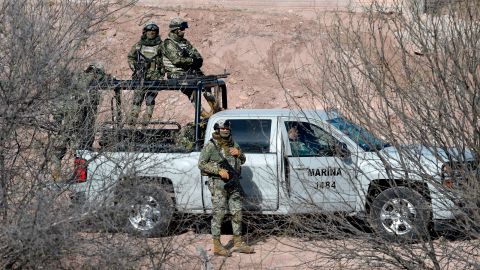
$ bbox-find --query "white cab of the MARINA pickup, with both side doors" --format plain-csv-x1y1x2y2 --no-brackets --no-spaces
203,110,357,214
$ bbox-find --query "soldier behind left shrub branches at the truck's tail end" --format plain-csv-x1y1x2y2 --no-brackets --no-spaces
50,63,111,181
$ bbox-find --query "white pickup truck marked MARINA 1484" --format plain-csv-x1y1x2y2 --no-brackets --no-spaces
71,109,472,239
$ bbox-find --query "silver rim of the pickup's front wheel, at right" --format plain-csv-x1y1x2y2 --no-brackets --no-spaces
380,198,417,235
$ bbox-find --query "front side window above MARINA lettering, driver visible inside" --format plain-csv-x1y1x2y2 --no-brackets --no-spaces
285,121,337,157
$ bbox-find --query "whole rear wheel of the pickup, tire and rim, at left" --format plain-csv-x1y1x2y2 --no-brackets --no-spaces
116,183,174,237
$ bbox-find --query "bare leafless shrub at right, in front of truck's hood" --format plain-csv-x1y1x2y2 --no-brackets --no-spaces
270,1,480,269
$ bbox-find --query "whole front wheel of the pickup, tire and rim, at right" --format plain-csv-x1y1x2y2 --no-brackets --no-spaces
369,187,431,242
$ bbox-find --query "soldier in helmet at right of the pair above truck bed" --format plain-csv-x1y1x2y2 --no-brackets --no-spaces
162,18,218,118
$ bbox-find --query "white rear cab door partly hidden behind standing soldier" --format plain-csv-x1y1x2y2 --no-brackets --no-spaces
202,119,279,211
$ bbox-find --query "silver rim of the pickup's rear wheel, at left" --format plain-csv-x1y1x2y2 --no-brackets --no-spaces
128,196,162,231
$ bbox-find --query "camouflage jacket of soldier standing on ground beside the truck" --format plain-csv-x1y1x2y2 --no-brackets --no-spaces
198,136,246,178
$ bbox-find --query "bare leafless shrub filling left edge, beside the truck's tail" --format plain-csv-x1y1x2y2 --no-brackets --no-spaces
0,0,191,269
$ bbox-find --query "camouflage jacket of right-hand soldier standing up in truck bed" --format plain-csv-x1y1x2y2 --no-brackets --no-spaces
162,32,203,74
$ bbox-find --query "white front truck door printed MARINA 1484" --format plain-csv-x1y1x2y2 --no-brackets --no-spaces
280,118,356,212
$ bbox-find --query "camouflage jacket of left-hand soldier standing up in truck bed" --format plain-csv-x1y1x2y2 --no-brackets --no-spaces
128,36,165,80
